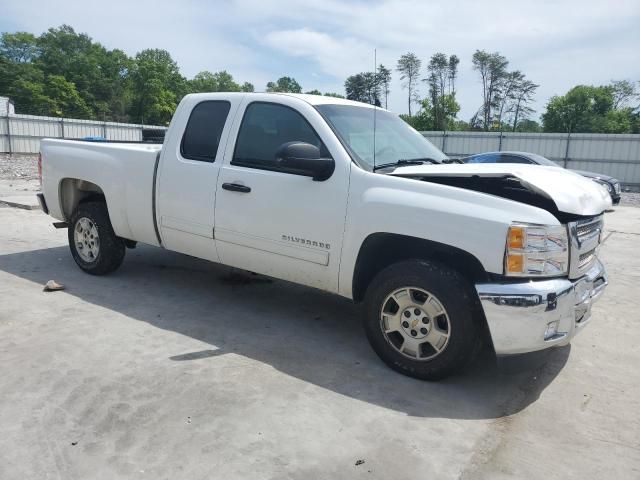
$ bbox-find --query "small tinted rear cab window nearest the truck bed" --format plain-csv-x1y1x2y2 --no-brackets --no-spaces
180,100,231,162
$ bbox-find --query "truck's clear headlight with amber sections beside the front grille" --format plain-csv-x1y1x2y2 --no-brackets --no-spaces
504,224,569,277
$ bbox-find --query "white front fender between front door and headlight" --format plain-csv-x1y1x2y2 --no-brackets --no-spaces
339,168,559,298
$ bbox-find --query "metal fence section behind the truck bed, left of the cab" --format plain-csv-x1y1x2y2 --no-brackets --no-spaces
0,114,166,154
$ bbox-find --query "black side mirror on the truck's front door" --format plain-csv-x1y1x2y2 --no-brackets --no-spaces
276,142,336,182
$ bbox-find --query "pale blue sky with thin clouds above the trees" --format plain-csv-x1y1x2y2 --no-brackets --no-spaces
0,0,640,120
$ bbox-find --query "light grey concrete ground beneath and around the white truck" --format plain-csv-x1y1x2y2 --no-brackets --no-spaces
0,207,640,480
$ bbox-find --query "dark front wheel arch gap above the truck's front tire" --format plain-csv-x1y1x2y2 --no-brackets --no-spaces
352,232,487,302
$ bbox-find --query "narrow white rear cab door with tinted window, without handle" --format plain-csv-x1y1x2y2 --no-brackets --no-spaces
156,94,243,262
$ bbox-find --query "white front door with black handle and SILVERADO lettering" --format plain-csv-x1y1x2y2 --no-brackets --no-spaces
215,95,351,291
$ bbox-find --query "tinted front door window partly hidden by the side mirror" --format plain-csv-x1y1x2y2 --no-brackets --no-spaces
231,102,329,171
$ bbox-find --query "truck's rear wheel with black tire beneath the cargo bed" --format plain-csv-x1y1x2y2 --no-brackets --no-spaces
68,202,126,275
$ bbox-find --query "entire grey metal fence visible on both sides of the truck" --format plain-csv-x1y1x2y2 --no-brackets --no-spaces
5,114,640,189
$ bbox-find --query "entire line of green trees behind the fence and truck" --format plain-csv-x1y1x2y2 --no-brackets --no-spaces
0,25,640,133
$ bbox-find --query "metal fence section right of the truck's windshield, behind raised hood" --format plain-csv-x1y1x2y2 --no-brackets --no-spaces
422,132,640,189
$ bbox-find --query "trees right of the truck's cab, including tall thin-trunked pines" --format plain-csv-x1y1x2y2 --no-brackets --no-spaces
345,50,640,133
